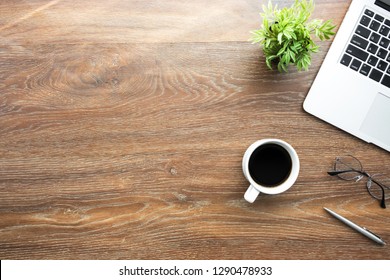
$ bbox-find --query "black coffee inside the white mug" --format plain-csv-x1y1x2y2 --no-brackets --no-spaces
249,143,292,187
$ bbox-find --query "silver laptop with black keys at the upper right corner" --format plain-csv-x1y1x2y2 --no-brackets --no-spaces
303,0,390,151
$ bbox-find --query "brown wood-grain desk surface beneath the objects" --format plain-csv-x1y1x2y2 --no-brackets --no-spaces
0,0,390,259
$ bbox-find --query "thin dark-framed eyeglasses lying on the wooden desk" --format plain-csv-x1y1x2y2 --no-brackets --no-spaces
328,155,390,208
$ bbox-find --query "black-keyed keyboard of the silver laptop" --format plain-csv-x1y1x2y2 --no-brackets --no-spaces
340,9,390,88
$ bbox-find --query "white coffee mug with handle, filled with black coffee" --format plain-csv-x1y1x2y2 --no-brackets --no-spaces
242,139,300,203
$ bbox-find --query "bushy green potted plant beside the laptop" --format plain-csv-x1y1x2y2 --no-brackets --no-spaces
251,0,336,72
